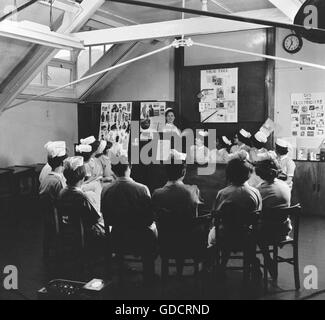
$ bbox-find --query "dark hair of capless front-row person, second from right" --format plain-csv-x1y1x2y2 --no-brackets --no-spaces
226,159,252,186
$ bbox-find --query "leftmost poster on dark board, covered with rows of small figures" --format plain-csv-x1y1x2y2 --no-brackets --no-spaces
99,102,132,156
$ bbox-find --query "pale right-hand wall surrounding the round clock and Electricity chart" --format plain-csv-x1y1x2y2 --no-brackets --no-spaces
275,29,325,148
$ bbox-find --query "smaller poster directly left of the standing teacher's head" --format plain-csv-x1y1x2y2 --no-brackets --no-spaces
140,102,166,140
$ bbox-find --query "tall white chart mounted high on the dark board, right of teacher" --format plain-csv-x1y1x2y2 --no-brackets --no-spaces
199,68,238,123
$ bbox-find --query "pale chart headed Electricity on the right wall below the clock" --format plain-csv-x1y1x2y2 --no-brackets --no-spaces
291,93,325,138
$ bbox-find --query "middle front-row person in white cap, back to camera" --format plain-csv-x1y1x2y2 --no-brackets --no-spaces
152,156,207,262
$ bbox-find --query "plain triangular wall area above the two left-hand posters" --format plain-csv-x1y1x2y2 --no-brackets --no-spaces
86,42,175,102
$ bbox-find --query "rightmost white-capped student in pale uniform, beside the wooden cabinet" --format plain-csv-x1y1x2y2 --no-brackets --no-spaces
275,139,296,189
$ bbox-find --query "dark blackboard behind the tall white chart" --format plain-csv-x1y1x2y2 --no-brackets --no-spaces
180,61,267,135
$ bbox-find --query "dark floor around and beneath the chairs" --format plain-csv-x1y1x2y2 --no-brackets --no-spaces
0,200,325,300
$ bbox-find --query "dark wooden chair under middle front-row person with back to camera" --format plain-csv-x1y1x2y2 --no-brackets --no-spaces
157,208,211,281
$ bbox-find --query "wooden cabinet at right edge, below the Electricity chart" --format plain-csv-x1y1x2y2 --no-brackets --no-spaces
293,161,325,216
